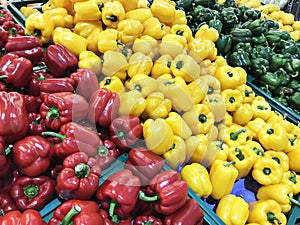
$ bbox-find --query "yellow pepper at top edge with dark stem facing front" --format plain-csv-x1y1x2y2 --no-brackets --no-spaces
102,1,125,28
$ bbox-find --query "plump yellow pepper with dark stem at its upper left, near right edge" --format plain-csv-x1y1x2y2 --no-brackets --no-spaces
257,123,289,151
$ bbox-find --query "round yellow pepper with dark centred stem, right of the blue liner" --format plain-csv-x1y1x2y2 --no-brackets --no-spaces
252,157,283,185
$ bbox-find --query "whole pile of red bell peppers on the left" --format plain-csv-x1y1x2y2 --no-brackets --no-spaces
0,12,203,225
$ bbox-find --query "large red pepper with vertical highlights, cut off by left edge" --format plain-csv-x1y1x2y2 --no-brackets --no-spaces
0,91,29,144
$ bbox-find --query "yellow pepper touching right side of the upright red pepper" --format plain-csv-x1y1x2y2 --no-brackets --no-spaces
119,90,147,116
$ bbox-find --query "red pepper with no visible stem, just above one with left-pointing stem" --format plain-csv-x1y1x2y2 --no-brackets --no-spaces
125,147,165,186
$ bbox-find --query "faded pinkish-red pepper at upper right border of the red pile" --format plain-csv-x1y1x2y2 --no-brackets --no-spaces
70,69,99,99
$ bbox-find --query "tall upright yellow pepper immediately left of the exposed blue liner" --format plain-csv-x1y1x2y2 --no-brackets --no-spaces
209,160,239,200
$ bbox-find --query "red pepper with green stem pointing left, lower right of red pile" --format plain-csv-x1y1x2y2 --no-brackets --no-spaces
139,170,188,215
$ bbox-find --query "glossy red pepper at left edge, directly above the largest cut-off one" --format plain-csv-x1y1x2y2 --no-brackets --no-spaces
0,53,33,88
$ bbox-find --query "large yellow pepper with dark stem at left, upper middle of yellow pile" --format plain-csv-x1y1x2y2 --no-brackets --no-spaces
171,54,200,82
